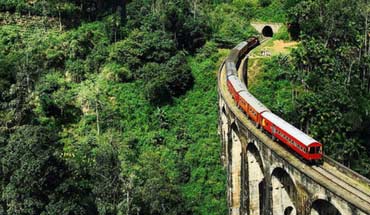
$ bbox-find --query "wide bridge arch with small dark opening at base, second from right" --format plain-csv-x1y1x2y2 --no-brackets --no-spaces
271,167,298,215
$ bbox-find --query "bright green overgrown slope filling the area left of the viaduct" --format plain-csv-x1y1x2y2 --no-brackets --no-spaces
0,0,280,215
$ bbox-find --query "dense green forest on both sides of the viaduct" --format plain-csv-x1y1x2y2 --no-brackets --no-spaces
0,0,370,215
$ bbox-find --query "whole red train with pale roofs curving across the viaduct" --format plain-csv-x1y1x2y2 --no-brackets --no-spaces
225,37,323,164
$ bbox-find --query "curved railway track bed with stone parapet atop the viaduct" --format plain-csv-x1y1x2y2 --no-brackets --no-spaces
218,36,370,214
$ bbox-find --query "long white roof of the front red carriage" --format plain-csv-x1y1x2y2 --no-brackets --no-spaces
262,112,318,146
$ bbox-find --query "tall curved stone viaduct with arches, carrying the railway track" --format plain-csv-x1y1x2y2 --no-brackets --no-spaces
218,41,370,215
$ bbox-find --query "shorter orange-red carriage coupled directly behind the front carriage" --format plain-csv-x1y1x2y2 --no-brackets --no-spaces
239,90,270,125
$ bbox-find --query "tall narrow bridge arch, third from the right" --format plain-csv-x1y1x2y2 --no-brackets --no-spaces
244,141,266,215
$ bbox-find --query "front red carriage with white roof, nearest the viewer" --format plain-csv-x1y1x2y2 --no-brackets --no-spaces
262,112,322,161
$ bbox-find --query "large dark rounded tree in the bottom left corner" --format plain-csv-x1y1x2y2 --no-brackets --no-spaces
1,125,66,214
